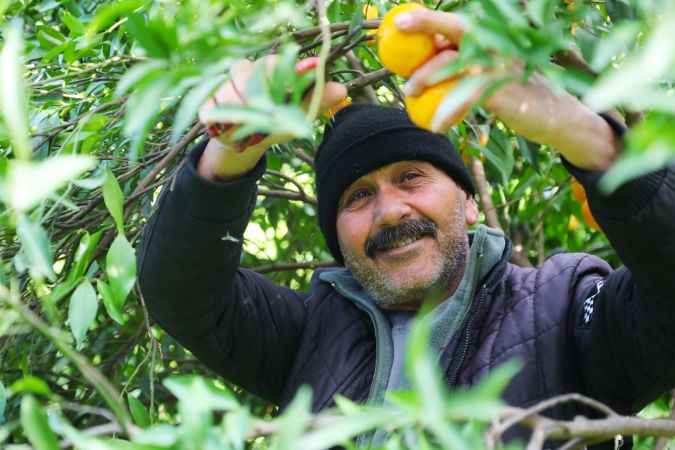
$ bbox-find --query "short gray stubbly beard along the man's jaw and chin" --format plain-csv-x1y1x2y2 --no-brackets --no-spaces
340,205,469,309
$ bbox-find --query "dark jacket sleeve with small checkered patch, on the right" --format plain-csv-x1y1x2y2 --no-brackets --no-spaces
568,118,675,413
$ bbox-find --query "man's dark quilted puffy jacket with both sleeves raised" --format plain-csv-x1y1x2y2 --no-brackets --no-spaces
139,139,675,448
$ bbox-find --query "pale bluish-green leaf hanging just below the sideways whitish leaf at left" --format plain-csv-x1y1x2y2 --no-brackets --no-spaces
16,216,55,280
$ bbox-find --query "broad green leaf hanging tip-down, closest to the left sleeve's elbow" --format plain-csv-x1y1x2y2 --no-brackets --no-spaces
105,234,136,311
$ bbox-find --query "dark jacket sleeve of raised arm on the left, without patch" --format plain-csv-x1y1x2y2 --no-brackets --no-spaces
138,144,305,402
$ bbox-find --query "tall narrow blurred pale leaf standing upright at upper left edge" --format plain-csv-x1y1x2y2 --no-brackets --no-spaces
0,20,32,159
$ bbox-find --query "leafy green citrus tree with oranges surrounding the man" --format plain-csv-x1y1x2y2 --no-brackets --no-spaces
0,0,675,450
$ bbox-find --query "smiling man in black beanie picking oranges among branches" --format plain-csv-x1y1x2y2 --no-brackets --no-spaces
139,5,675,448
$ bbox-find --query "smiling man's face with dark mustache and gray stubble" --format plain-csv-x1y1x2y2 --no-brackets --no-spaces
337,161,478,309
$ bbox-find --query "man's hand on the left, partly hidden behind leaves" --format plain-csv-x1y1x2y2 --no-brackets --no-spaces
197,55,347,181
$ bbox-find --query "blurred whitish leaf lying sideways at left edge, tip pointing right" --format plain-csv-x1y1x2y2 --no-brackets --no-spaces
6,155,96,211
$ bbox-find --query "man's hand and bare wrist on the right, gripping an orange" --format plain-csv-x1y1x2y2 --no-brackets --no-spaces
394,8,619,170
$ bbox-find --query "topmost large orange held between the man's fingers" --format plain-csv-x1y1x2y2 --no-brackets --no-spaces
377,3,436,78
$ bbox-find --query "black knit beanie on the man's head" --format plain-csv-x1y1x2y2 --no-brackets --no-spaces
315,104,476,264
